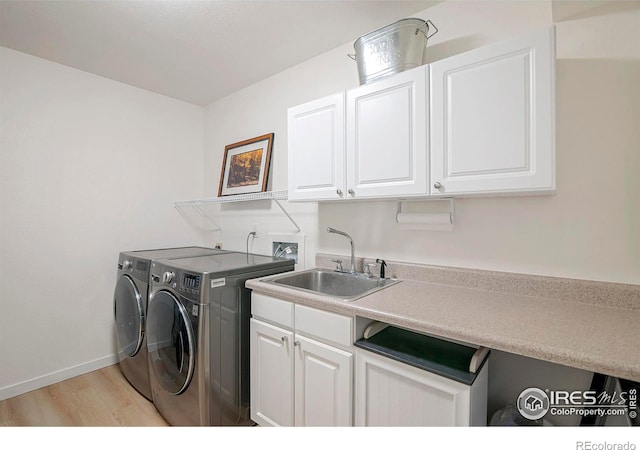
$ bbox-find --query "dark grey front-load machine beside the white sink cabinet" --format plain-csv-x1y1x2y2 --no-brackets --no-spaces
147,252,294,426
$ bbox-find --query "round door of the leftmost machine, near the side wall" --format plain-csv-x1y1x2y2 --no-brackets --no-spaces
113,275,144,357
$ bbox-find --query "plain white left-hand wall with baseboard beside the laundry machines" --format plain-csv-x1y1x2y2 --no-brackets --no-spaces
0,47,203,399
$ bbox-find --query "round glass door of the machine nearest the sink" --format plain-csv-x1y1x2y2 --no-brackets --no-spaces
147,291,196,395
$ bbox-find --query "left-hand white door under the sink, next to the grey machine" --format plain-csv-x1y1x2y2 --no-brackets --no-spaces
250,319,293,426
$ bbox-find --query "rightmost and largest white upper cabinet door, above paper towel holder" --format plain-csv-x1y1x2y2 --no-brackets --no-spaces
430,28,555,195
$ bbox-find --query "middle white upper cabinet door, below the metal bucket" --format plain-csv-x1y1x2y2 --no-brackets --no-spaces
346,66,428,198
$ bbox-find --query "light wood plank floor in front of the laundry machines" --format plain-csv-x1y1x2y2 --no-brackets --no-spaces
0,365,168,427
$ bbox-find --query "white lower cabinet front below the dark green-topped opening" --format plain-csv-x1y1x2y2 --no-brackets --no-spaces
355,349,470,426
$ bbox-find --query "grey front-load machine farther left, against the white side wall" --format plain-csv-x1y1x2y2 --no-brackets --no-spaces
113,247,228,400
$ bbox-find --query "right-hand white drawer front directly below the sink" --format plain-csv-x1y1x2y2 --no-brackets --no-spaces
295,305,353,347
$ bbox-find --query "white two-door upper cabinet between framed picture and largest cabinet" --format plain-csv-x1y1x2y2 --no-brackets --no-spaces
288,66,428,200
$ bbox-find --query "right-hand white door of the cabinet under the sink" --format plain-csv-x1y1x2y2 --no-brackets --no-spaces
295,335,353,426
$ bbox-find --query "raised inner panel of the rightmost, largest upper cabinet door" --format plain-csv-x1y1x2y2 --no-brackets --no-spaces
445,52,532,176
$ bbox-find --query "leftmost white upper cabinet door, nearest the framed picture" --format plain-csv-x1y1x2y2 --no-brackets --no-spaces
288,93,345,200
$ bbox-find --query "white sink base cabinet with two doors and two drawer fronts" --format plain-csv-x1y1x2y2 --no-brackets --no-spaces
250,293,353,426
